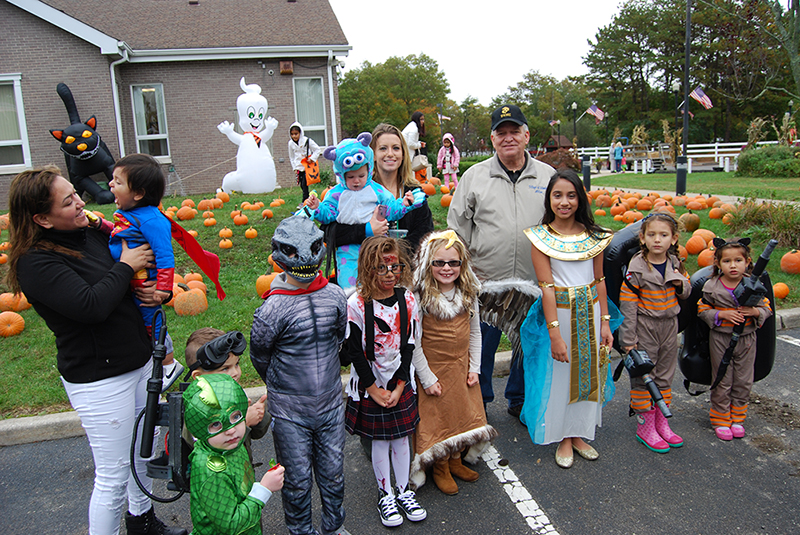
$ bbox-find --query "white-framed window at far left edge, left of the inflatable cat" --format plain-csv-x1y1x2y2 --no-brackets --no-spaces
0,74,32,173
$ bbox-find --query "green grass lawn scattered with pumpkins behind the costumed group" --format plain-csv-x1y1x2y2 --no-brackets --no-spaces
0,182,800,418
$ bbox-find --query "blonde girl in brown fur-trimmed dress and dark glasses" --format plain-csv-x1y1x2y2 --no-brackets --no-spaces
411,230,497,495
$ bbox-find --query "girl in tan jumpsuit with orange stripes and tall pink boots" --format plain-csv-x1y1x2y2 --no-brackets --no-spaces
619,213,692,453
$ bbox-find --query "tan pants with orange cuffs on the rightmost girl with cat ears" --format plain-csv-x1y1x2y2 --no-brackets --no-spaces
708,330,756,427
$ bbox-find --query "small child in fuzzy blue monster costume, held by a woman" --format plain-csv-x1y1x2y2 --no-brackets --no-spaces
305,132,425,290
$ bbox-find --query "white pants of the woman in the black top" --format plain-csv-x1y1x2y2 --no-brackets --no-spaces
61,360,153,535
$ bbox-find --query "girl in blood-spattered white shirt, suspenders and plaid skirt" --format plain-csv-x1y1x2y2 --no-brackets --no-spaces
344,237,427,527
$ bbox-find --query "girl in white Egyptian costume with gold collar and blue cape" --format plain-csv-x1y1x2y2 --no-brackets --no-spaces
521,170,621,468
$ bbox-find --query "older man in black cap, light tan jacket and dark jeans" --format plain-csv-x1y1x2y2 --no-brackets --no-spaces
447,104,555,417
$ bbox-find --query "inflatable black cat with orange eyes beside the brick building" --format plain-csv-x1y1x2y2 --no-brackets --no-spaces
50,83,114,204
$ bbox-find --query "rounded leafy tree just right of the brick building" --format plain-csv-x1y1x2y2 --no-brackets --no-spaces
339,54,450,137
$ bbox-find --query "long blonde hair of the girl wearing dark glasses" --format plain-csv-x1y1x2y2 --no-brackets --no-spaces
414,229,481,313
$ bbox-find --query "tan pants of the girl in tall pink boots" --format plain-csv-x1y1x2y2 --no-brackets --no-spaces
631,315,678,412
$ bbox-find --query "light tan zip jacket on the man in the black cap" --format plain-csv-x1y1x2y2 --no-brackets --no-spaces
447,154,555,281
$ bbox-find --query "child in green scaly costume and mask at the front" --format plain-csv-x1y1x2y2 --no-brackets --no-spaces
183,374,284,535
